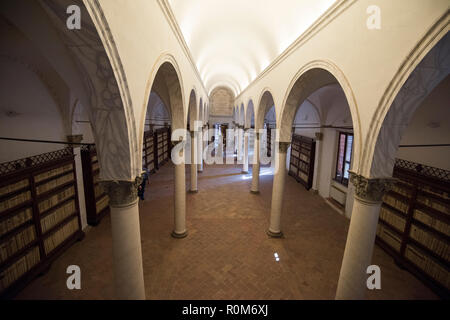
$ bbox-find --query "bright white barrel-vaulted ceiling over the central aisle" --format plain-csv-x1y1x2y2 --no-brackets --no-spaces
168,0,336,95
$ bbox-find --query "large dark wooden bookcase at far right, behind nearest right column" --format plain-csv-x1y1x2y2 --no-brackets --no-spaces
377,159,450,299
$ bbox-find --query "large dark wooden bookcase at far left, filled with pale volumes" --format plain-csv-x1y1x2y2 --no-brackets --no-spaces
0,148,84,299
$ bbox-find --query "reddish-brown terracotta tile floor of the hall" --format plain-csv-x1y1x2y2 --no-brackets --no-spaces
16,164,437,299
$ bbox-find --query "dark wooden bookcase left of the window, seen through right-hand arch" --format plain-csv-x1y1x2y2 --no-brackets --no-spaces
289,134,316,190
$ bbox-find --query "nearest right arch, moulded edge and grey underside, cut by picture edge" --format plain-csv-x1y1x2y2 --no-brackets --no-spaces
361,21,450,178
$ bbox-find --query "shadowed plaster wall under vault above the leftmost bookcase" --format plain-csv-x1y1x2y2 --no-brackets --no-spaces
0,59,69,162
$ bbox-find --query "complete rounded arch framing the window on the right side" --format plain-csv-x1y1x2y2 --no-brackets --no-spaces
278,60,361,171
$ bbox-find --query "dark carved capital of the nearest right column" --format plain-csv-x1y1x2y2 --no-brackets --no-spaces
349,171,395,203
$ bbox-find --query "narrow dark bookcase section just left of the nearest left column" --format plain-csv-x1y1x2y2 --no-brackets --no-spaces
81,145,110,226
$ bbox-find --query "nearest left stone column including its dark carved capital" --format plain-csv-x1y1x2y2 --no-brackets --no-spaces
102,177,145,300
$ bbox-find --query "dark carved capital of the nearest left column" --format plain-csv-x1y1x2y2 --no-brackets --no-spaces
101,177,142,208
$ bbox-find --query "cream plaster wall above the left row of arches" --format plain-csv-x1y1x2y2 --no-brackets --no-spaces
99,0,209,144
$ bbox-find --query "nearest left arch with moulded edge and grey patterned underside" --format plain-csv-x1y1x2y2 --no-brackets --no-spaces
2,0,141,181
